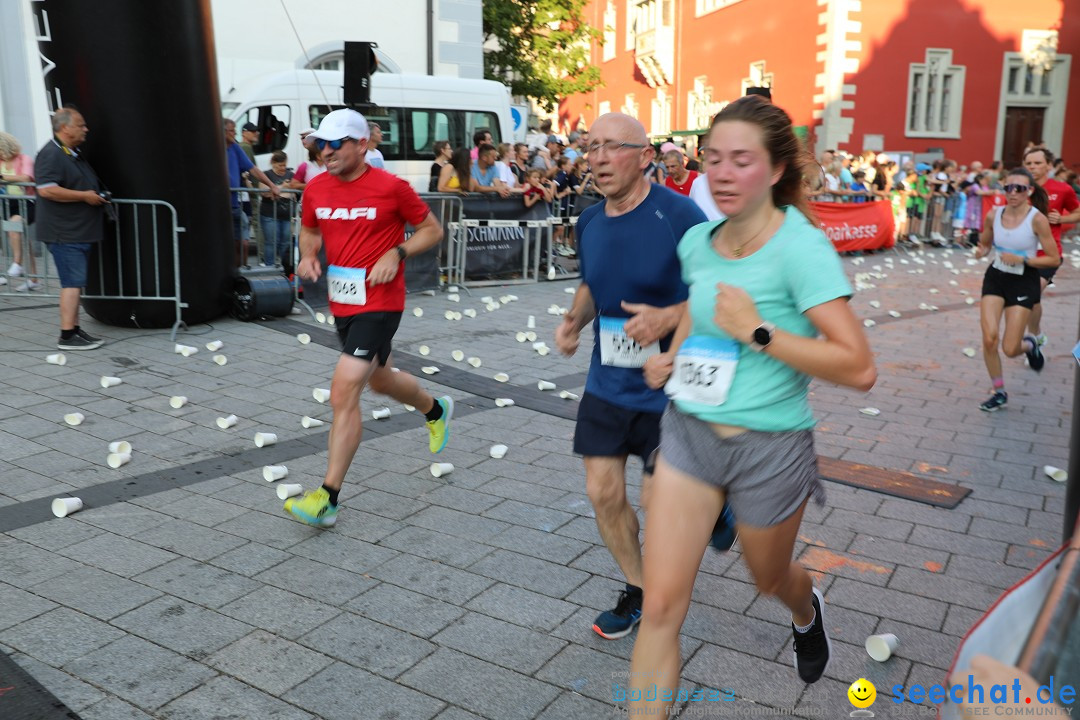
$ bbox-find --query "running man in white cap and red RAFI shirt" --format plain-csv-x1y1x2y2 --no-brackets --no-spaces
285,110,454,527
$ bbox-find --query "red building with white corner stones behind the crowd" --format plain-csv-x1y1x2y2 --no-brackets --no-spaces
559,0,1080,165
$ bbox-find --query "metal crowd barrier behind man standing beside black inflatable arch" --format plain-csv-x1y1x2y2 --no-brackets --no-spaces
0,185,187,340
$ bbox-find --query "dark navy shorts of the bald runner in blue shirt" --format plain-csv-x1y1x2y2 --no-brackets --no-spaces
573,393,663,472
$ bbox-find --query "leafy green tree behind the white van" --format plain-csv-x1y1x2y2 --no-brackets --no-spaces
484,0,602,110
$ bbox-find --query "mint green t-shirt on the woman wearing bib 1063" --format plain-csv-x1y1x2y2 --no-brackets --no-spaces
674,206,852,432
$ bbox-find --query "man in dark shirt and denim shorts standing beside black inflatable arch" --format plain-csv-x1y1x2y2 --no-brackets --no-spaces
35,108,109,350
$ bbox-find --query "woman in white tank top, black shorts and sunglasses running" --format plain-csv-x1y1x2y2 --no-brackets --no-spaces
975,167,1062,412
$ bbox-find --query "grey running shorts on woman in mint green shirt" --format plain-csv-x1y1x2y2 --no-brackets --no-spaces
660,403,825,528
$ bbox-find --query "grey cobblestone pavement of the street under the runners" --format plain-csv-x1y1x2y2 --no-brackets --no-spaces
0,239,1078,720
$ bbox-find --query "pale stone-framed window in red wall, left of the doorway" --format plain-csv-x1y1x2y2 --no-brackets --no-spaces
905,47,967,138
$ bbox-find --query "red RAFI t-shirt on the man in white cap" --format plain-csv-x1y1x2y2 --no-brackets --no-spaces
301,166,431,317
